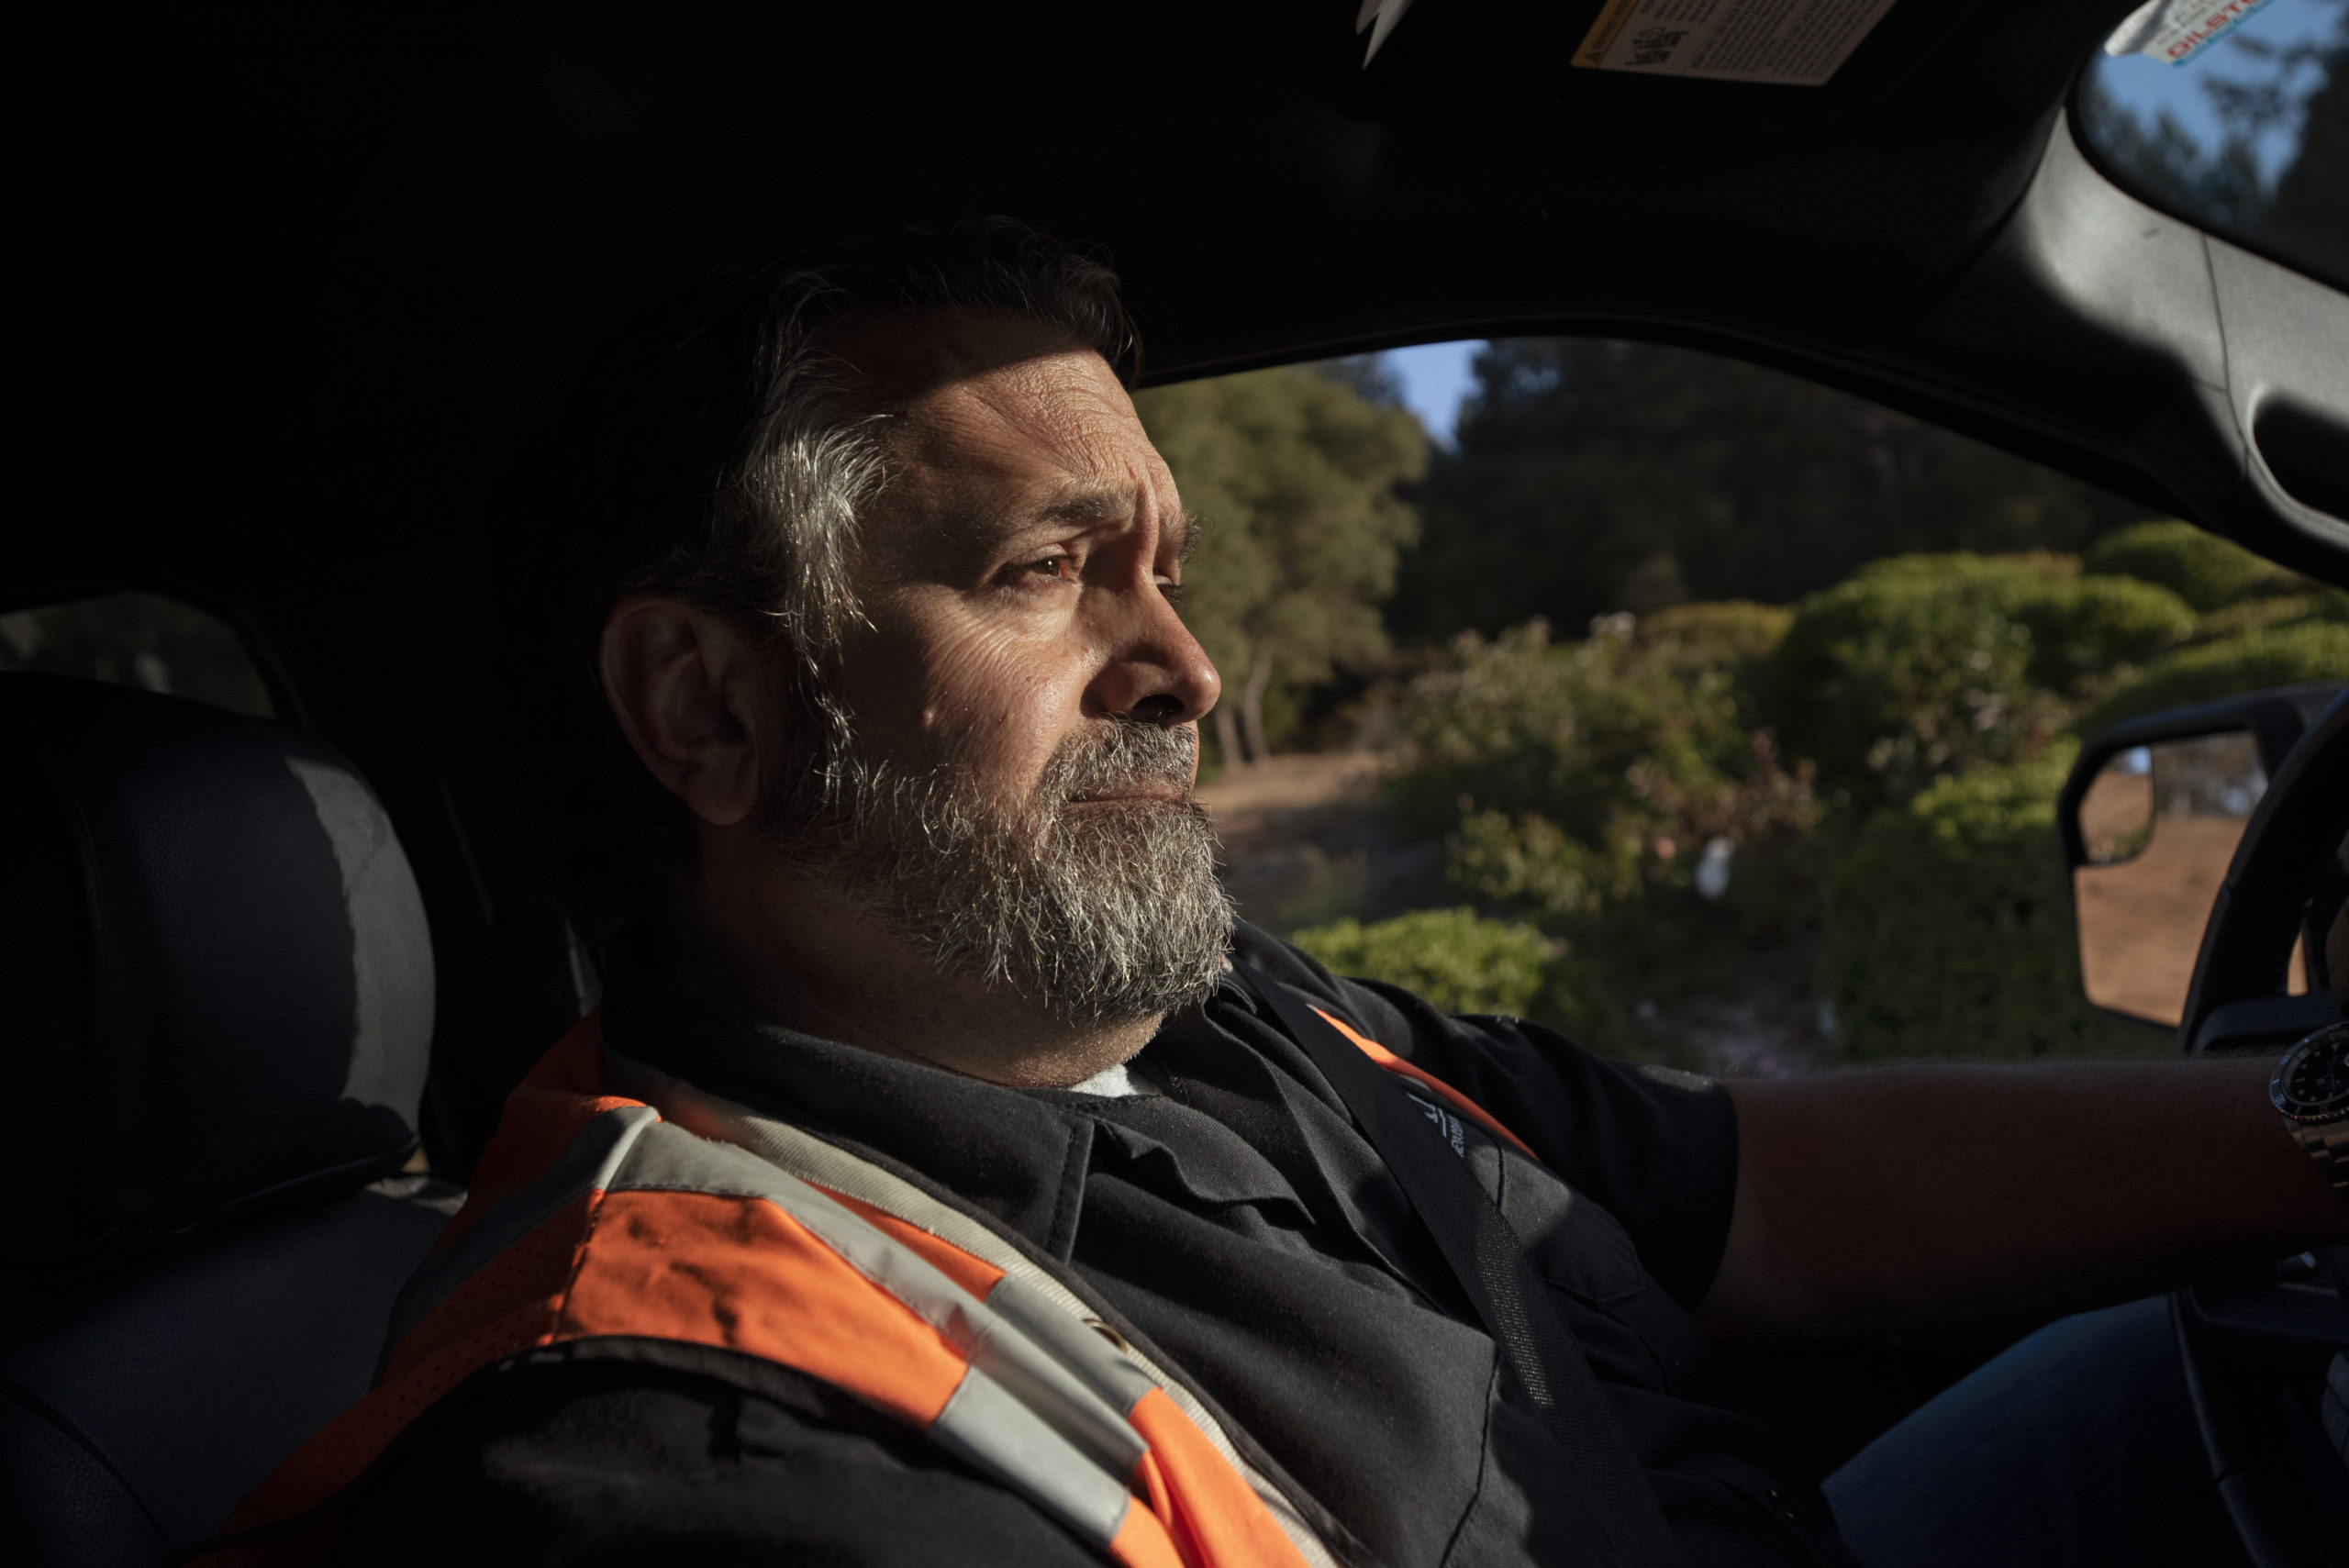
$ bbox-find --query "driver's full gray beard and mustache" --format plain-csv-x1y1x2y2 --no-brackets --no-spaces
761,720,1233,1026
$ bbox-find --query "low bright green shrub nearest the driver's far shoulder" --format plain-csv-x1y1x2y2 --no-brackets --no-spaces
1289,908,1631,1050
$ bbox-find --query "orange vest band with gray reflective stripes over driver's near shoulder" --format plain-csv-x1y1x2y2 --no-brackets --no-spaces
228,1017,1332,1568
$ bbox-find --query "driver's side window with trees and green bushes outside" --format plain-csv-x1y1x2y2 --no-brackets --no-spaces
1137,338,2349,1073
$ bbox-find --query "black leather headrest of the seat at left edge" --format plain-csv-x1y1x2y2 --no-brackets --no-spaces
0,673,432,1268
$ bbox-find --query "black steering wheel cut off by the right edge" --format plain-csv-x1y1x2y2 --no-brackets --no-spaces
2170,693,2349,1568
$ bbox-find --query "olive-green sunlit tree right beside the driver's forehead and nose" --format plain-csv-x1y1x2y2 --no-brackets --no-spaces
1134,366,1428,761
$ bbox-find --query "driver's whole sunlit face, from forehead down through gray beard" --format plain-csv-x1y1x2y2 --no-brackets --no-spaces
763,317,1230,1023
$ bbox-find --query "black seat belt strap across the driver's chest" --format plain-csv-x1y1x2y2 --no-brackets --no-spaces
1233,962,1679,1568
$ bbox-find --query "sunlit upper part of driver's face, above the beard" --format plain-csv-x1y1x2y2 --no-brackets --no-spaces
841,315,1219,800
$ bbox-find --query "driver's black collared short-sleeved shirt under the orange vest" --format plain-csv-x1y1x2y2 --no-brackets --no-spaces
345,928,1849,1568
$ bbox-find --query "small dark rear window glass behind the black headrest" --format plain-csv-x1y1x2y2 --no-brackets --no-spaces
0,594,273,718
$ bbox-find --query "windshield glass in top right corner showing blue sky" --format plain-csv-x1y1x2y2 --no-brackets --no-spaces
2079,0,2349,289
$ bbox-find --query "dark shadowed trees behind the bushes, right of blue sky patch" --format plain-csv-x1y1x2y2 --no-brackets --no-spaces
1388,338,2140,640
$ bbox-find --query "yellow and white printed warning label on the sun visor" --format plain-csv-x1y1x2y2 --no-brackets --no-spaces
1574,0,1893,87
